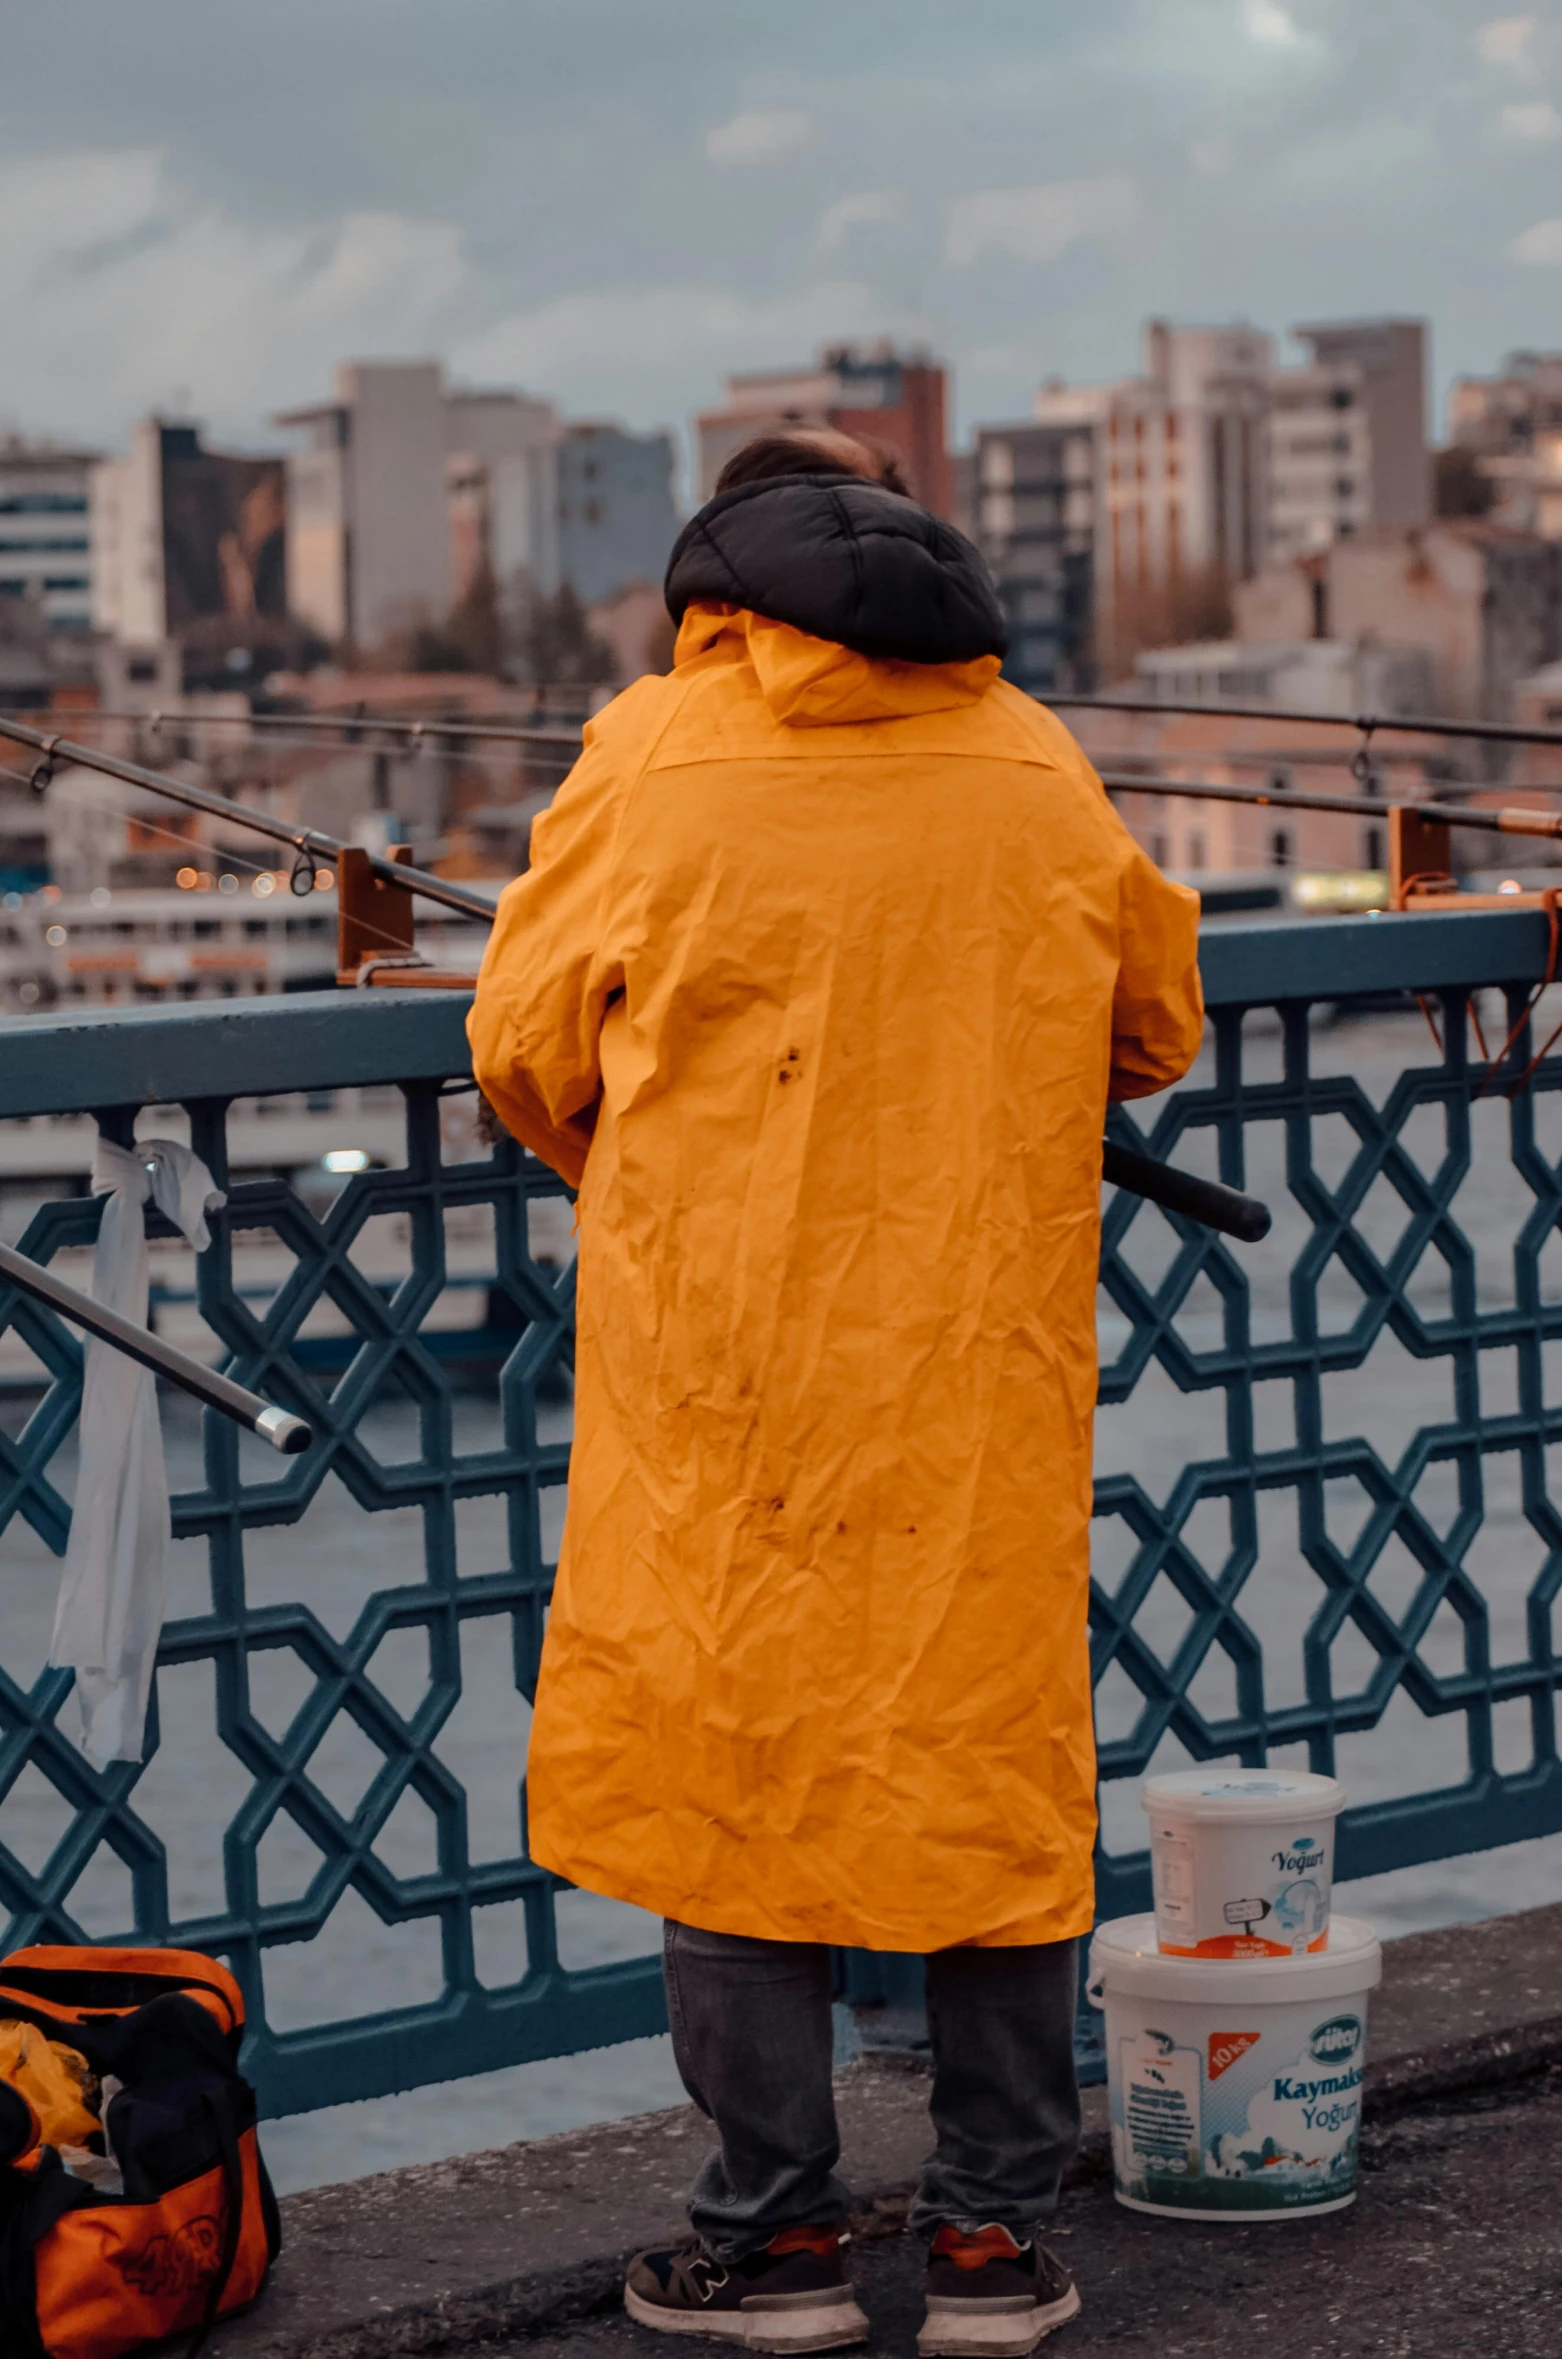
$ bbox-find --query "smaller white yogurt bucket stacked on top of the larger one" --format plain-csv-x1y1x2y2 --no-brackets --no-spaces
1144,1769,1345,1958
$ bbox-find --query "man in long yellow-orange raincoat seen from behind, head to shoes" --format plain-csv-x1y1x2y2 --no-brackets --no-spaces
470,434,1201,2354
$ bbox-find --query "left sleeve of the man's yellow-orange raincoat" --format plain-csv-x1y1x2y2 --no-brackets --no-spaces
467,729,625,1187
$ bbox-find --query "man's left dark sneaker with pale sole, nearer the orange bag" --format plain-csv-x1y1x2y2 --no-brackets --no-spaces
623,2227,868,2352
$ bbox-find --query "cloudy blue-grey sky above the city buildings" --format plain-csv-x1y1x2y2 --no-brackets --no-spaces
0,0,1562,478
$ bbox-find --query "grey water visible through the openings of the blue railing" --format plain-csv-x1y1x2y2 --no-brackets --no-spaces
2,1014,1562,2189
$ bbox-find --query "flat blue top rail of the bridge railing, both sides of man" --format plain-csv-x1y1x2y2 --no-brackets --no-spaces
0,908,1548,1118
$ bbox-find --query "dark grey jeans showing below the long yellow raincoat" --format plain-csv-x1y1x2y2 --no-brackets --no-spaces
663,1923,1078,2262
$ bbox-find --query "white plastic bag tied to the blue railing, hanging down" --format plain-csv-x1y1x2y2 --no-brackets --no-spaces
50,1137,224,1762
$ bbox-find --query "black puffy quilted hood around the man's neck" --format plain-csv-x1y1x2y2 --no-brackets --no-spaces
665,474,1008,663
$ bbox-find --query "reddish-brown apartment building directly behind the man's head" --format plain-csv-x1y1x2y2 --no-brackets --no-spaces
694,344,956,517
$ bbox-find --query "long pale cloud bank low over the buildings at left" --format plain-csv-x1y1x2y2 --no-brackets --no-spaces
0,149,915,446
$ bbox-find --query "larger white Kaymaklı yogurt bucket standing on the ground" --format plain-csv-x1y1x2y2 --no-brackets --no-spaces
1090,1916,1383,2220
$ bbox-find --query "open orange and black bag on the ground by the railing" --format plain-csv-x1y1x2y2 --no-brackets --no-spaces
0,1949,281,2359
